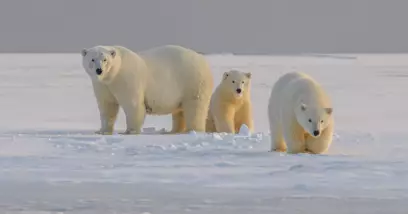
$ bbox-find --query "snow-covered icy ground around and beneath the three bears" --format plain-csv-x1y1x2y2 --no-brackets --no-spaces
0,54,408,214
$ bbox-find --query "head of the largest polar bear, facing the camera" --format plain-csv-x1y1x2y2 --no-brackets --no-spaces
81,46,119,83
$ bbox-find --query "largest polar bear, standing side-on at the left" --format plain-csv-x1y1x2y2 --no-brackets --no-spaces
82,45,213,134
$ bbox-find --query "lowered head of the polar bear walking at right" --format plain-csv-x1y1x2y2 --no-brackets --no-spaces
295,102,333,137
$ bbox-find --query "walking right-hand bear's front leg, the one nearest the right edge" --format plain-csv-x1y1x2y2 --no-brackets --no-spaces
306,124,333,154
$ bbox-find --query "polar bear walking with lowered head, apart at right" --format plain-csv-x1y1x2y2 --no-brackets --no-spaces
268,72,334,154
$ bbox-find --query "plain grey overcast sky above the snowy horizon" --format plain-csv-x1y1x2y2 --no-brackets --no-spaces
0,0,408,54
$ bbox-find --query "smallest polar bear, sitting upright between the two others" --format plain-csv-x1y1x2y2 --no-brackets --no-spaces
206,70,254,134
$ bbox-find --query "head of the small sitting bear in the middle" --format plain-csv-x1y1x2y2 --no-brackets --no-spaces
221,70,251,98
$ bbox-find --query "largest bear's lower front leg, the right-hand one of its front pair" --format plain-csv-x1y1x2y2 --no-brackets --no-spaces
121,102,146,135
